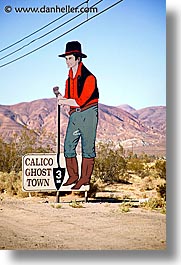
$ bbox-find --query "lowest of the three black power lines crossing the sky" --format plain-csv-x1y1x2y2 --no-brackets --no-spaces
0,0,123,68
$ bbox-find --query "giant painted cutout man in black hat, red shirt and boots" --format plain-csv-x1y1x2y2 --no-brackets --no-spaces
59,41,99,190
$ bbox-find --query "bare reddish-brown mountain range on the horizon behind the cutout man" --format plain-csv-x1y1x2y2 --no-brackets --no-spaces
0,98,166,155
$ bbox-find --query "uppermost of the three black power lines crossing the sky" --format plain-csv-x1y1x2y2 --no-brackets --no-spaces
0,0,89,53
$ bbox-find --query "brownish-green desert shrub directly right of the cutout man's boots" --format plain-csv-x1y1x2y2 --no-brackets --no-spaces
93,142,126,183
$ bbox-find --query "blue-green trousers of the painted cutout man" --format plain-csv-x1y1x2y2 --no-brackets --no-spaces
64,106,98,158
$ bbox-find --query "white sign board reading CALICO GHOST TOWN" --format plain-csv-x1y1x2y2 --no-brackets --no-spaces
22,153,89,192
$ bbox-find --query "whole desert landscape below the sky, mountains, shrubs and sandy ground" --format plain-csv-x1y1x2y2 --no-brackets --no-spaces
0,98,166,250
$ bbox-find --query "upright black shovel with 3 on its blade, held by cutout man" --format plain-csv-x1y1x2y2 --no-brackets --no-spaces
53,87,65,192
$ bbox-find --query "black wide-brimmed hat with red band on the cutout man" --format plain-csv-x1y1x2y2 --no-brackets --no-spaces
58,41,87,58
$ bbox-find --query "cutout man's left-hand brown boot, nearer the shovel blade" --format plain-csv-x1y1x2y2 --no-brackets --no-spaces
63,157,79,186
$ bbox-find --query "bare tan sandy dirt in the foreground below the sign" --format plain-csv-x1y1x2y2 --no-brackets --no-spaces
0,193,166,250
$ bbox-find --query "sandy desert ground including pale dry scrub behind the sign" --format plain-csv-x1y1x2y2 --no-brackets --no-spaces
0,167,166,250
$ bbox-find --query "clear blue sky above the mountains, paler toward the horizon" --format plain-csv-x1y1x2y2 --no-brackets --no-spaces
0,0,166,109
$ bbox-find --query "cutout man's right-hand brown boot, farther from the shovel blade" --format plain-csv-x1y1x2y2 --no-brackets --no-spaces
72,157,94,190
